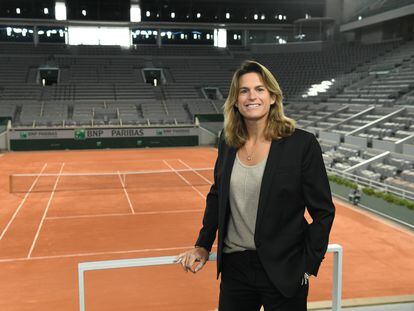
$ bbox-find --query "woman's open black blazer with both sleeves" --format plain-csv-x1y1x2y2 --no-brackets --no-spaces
196,129,335,297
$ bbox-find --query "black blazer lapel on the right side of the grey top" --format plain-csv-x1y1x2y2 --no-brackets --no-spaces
255,138,284,238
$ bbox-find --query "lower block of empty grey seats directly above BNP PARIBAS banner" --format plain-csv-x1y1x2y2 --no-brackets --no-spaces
0,99,222,127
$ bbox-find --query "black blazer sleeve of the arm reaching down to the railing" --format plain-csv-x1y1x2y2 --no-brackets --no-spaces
195,134,223,252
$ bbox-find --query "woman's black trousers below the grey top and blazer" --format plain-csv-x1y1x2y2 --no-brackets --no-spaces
218,251,309,311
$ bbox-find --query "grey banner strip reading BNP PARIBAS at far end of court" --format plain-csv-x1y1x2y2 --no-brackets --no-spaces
9,127,199,140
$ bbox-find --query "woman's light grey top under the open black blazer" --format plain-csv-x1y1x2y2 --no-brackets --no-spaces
223,156,267,253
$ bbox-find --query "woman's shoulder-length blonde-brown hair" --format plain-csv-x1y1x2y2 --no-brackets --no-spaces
224,60,295,148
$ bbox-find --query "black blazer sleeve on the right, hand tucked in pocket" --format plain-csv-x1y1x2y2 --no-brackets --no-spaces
302,135,335,276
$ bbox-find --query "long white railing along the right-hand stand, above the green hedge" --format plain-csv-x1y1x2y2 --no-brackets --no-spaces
326,167,414,200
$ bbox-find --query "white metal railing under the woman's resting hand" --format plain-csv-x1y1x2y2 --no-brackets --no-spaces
78,244,342,311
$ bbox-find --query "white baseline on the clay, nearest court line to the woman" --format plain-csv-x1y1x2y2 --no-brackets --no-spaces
0,245,217,263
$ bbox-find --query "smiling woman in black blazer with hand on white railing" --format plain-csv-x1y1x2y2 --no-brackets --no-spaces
177,61,335,311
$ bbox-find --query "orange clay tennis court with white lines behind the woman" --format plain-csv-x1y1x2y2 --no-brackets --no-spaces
0,148,414,311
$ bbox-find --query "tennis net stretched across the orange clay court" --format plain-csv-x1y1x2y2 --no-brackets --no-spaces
9,168,213,193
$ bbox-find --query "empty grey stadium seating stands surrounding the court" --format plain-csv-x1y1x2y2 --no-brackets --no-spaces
0,33,414,199
